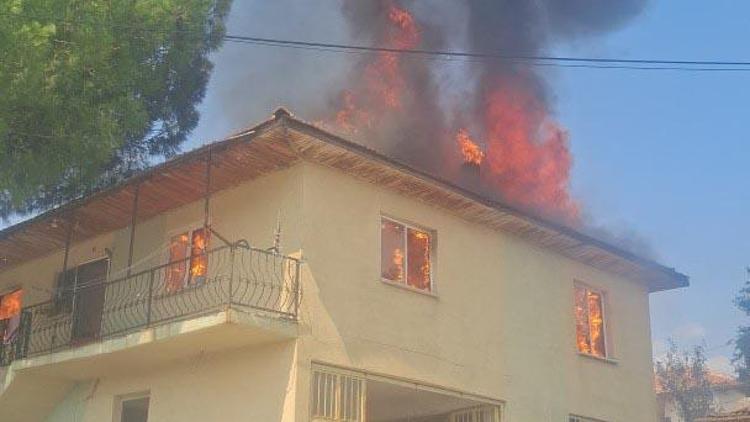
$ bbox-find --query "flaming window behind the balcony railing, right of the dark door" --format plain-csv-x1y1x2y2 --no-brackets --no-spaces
166,228,209,292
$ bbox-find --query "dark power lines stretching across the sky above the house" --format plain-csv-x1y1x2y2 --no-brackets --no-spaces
0,13,750,72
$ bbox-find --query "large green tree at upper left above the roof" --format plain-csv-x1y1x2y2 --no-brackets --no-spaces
0,0,231,217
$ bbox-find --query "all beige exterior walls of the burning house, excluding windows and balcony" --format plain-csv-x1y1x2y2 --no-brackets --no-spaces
0,163,656,422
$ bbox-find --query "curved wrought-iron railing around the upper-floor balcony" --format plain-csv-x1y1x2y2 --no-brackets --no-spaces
0,241,300,366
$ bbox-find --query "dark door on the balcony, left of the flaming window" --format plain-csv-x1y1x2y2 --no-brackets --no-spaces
71,259,109,343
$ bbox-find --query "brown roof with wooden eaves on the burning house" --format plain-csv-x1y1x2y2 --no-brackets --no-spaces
0,109,688,292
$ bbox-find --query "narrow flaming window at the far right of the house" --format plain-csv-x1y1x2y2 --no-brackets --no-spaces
575,284,607,358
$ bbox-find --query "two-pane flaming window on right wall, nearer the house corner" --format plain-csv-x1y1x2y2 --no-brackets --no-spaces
380,218,434,291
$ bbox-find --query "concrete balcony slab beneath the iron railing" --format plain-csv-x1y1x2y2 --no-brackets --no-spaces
0,308,298,422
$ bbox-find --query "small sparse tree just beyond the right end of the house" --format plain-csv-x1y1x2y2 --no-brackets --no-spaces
655,340,713,422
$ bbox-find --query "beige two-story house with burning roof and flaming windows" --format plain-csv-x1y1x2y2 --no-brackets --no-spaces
0,110,687,422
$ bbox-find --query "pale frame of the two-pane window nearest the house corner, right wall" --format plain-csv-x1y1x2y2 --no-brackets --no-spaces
378,213,437,297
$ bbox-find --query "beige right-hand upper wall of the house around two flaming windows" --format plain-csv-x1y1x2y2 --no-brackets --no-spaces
299,165,656,421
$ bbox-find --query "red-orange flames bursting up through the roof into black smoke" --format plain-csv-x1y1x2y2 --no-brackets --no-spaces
324,0,579,224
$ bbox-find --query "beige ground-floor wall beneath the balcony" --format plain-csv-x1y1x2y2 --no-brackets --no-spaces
42,342,296,422
